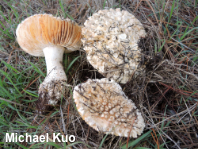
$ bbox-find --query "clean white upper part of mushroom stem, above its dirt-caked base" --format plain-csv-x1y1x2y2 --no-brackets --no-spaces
43,46,67,83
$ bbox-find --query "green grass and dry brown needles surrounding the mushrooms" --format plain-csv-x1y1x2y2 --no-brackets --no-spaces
0,0,198,149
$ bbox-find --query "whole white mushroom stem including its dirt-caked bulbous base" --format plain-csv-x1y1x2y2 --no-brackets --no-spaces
36,46,67,113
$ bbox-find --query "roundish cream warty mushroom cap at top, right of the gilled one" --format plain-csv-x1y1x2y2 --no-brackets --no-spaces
82,8,146,83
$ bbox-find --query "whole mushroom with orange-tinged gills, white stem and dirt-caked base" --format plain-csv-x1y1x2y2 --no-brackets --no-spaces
16,14,81,112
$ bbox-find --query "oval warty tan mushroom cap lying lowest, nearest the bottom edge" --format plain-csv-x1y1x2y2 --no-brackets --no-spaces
73,78,145,138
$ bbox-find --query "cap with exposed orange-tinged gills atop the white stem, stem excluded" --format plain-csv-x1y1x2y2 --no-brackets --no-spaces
16,14,81,56
